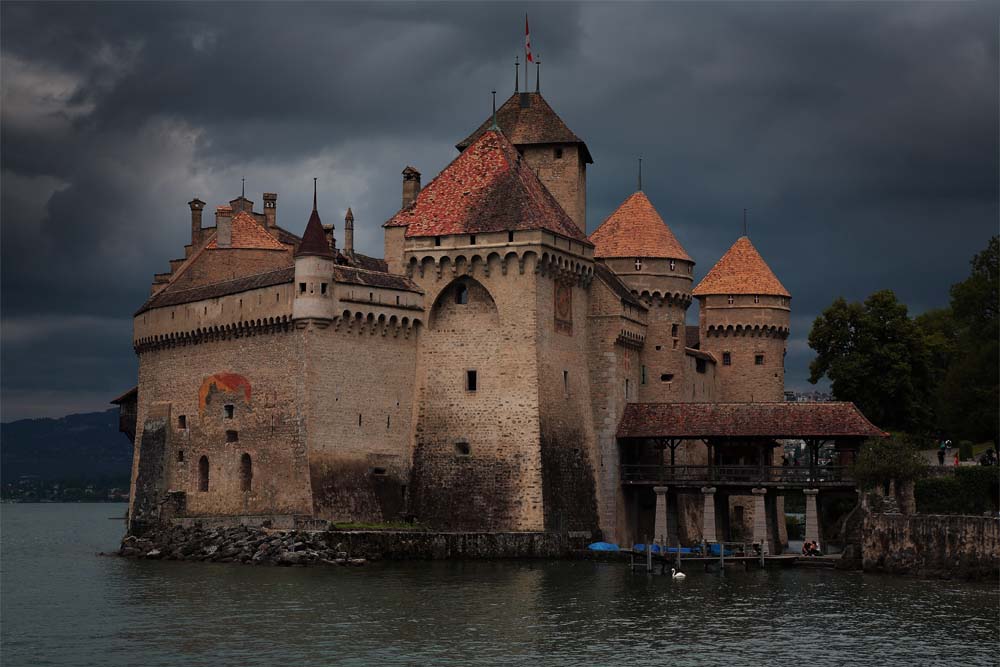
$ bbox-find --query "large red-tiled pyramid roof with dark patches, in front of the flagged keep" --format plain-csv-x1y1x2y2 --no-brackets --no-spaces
380,130,589,245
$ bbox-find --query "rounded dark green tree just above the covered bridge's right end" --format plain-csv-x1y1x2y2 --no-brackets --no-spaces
809,290,932,433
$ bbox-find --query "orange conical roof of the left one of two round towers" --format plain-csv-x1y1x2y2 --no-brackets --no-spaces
590,190,691,262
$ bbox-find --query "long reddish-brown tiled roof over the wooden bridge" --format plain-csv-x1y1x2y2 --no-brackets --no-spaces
618,402,888,438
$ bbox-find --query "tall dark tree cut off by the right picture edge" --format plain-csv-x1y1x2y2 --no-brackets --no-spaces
936,236,1000,443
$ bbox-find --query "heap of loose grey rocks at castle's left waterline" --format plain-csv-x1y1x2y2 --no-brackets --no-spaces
118,526,372,567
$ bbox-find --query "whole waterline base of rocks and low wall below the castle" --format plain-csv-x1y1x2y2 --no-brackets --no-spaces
118,524,592,566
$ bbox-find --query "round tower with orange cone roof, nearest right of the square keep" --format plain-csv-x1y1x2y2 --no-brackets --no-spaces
590,190,694,403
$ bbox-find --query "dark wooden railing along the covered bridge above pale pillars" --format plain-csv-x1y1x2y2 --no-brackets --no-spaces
622,463,853,485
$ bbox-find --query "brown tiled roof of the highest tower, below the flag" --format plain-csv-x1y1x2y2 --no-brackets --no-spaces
455,93,594,164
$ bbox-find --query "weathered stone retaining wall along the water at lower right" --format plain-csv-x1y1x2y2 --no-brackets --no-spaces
861,514,1000,579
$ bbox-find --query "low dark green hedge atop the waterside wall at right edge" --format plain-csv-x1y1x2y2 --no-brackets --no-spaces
913,466,1000,515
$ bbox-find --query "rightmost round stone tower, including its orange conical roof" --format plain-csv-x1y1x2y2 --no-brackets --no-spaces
693,236,791,402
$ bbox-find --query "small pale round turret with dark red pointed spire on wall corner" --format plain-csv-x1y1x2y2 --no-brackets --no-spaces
292,179,336,324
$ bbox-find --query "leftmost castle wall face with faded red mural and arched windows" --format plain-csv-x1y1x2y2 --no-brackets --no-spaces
133,324,312,515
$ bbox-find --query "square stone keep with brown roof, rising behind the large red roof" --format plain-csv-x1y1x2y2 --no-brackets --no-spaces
455,92,594,234
